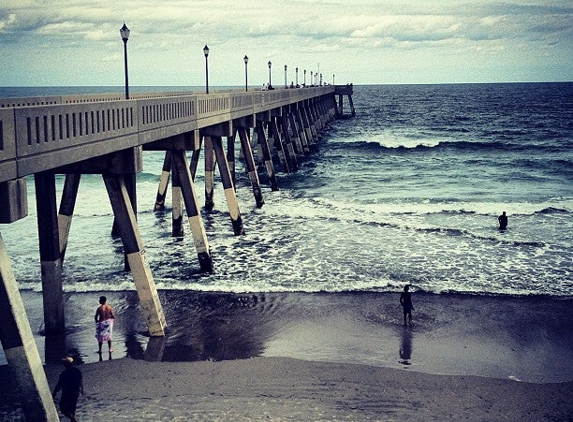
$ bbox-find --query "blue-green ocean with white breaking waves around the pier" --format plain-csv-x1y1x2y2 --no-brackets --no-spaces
0,83,573,372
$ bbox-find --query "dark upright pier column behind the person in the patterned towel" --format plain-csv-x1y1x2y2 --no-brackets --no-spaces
34,172,65,335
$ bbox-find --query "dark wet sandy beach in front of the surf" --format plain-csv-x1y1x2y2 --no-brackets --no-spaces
0,292,573,421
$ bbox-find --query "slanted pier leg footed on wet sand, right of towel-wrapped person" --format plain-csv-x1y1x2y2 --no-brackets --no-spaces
102,174,167,336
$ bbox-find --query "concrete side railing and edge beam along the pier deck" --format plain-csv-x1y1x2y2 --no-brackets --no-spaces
0,86,335,183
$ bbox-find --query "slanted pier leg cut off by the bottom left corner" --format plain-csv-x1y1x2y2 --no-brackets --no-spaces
0,234,60,422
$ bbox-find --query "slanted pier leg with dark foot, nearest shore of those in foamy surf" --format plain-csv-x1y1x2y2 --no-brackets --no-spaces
172,151,213,272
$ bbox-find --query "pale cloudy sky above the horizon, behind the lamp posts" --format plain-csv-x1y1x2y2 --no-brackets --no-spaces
0,0,573,86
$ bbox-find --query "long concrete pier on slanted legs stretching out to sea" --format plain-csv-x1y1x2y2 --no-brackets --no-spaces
0,85,355,421
